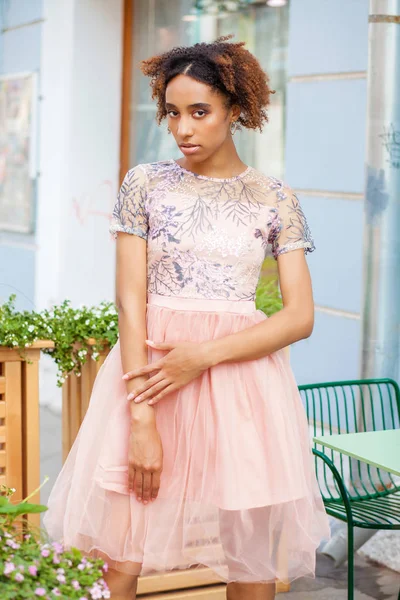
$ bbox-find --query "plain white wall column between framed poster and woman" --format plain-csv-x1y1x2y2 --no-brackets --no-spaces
36,0,123,308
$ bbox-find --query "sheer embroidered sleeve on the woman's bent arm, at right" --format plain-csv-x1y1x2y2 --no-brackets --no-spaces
271,188,315,259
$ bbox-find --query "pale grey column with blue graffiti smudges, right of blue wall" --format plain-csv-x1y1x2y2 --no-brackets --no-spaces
361,0,400,381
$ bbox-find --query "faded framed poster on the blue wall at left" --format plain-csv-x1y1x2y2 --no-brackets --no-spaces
0,73,37,233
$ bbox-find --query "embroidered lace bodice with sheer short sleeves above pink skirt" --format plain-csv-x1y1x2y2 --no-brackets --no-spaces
110,160,314,300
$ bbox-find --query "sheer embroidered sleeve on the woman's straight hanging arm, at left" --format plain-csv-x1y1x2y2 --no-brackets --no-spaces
110,165,148,240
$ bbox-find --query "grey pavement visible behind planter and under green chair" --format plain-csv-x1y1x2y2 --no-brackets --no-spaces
40,406,400,600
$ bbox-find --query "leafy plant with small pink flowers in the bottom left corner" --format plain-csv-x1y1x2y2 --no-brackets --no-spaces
0,486,110,600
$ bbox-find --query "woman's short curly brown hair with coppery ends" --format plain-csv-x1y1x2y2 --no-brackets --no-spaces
140,35,274,131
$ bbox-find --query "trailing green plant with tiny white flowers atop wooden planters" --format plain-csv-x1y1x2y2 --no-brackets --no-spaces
0,295,118,386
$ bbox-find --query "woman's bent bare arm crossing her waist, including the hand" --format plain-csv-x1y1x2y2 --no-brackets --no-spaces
125,249,314,404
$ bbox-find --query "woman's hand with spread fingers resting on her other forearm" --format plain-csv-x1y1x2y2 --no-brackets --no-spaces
122,340,210,404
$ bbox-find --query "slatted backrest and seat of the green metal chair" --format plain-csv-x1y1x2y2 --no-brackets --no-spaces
299,379,400,500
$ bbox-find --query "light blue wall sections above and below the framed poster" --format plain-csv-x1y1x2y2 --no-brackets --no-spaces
0,0,43,309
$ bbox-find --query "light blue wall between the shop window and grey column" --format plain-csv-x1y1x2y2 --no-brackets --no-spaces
286,0,368,383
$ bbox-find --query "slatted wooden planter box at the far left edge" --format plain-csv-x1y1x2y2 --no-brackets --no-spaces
0,340,54,526
